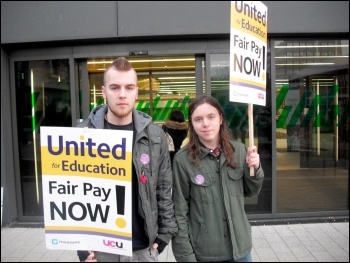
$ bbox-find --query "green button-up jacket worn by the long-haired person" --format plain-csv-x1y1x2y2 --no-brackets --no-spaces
172,141,264,262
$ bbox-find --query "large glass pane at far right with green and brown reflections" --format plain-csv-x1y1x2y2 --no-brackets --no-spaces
274,40,349,213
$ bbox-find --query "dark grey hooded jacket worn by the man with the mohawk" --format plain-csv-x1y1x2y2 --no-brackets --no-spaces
77,105,178,247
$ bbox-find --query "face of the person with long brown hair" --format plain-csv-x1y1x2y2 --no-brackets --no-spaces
191,103,222,149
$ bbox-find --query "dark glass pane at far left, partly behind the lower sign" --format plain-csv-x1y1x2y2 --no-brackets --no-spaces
15,59,72,216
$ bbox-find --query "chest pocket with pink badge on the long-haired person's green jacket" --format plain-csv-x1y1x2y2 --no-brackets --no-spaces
190,173,220,203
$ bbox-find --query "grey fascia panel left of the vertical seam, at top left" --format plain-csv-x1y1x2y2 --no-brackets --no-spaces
1,1,117,44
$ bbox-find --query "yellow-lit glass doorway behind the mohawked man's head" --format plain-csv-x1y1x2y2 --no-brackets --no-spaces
87,55,205,124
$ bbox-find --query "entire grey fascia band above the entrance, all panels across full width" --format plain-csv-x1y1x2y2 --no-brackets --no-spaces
1,1,349,44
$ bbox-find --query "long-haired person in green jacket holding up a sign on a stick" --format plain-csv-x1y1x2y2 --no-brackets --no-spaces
172,96,264,262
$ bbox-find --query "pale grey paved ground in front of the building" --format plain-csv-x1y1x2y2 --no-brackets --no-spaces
1,221,349,262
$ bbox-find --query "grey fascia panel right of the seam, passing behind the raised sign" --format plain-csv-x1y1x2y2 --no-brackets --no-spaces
118,1,349,37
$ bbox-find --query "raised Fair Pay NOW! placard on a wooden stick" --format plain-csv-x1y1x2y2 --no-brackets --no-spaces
230,1,267,175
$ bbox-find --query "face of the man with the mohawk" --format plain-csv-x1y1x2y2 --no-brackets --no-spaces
102,68,138,118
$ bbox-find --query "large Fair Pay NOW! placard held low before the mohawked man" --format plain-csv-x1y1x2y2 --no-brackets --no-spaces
40,127,133,256
